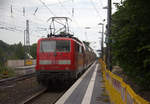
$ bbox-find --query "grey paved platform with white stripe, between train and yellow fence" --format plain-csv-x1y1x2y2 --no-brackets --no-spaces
55,62,110,104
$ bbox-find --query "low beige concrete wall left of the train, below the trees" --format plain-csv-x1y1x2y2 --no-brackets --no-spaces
7,60,36,68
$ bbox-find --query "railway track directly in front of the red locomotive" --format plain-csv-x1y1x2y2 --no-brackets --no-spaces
20,82,73,104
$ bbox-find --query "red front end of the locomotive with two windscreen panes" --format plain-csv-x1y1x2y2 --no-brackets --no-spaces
36,37,74,83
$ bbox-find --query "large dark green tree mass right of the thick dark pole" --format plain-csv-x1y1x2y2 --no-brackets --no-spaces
110,0,150,89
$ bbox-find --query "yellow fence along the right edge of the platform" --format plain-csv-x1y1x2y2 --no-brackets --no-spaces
99,59,150,104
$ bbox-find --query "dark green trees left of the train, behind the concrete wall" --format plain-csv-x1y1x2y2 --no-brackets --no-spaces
0,40,36,61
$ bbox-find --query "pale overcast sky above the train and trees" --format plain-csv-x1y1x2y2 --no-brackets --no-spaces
0,0,119,49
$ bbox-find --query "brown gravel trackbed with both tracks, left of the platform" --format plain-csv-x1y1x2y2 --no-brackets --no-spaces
0,73,68,104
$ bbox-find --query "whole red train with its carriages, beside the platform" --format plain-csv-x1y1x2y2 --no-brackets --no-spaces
36,35,96,85
